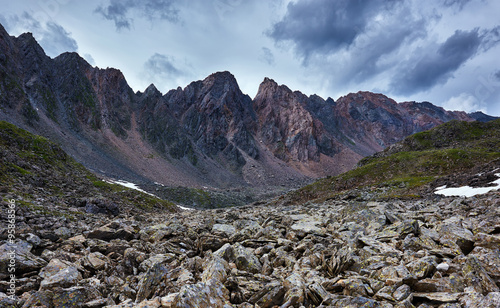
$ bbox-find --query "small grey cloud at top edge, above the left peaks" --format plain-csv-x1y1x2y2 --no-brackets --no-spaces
95,0,179,30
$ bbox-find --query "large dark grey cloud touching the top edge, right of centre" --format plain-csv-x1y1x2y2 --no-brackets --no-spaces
267,0,394,62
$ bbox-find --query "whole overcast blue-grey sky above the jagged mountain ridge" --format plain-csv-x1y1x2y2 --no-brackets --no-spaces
0,0,500,116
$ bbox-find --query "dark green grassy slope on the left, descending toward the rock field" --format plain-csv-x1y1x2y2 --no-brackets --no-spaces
0,121,177,211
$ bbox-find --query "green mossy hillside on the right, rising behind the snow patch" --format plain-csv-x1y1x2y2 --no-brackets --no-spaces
288,120,500,203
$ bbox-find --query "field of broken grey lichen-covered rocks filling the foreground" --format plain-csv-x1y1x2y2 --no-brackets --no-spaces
0,192,500,308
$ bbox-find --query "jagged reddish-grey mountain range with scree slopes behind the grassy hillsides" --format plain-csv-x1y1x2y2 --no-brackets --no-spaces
0,25,498,188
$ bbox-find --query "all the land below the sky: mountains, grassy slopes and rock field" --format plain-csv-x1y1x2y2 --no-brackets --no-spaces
0,22,500,308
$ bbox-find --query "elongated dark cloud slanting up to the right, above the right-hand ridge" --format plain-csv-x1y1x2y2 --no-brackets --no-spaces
391,29,481,95
